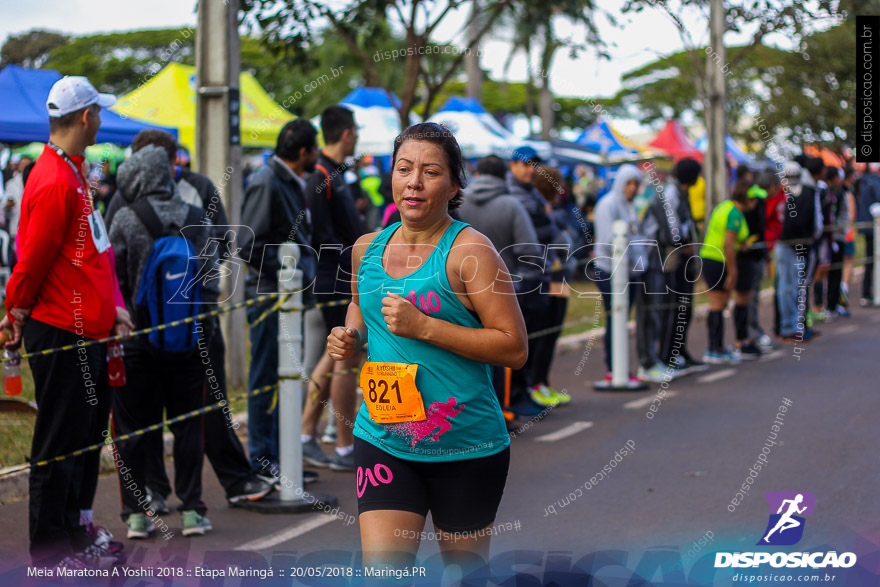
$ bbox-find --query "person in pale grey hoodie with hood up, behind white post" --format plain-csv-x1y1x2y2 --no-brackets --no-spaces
593,164,642,382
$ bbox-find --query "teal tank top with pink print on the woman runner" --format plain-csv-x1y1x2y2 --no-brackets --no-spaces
354,220,510,462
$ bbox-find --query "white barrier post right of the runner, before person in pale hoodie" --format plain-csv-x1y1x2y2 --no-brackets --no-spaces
605,220,629,387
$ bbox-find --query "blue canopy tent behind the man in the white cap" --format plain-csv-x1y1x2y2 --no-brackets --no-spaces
0,65,177,145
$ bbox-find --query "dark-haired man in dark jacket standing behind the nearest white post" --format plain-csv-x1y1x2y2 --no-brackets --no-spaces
238,118,318,474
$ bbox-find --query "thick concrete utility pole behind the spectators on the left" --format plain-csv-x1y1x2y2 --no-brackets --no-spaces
193,0,245,387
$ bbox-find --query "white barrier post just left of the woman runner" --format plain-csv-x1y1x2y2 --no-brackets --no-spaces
277,243,303,502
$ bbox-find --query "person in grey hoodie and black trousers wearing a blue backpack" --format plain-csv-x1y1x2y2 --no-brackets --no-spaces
110,145,219,538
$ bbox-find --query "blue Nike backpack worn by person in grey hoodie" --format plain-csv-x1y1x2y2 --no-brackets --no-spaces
130,198,203,352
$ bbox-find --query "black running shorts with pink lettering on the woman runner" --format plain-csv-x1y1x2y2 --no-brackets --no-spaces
354,437,510,532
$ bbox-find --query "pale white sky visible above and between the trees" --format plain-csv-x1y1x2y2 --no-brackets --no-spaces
0,0,804,134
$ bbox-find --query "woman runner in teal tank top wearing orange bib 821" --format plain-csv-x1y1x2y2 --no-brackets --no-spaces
327,123,528,568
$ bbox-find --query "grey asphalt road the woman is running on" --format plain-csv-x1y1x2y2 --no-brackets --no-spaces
0,300,880,586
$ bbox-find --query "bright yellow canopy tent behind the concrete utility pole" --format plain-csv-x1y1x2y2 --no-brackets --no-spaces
112,63,296,153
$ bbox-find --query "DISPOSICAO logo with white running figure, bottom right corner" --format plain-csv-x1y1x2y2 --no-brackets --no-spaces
715,491,856,569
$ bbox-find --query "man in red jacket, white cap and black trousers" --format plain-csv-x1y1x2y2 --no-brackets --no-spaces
0,77,131,569
